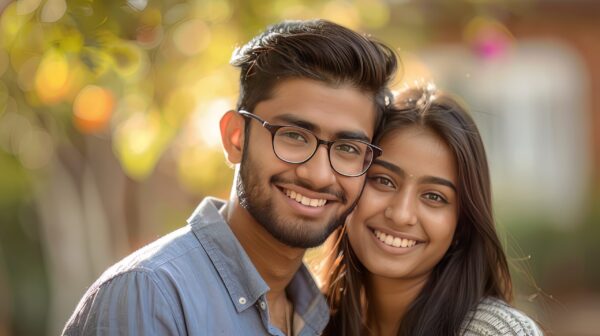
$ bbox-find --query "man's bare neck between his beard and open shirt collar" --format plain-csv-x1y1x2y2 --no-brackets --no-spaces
223,199,306,301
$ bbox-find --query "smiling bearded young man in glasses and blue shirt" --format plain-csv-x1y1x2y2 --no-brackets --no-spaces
63,20,396,335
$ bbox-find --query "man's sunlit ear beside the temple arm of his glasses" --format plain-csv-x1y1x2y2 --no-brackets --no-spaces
219,110,245,164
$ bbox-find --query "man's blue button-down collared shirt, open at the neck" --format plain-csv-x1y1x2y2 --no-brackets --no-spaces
63,198,329,336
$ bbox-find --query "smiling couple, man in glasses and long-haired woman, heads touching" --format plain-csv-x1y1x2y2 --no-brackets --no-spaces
63,20,541,335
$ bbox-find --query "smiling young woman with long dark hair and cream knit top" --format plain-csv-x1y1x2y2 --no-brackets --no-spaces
321,87,542,336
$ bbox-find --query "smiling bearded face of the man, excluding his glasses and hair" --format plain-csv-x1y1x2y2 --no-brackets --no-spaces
236,79,375,248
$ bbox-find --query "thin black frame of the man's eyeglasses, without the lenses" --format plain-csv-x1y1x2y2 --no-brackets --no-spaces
238,110,383,177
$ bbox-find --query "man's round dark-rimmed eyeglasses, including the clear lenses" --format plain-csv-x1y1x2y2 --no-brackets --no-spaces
239,110,382,177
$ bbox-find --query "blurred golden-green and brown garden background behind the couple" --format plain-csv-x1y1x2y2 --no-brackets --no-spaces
0,0,600,335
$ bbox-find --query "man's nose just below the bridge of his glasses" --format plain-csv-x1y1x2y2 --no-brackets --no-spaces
296,146,336,190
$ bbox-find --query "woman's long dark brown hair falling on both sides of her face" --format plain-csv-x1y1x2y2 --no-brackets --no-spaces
320,86,512,336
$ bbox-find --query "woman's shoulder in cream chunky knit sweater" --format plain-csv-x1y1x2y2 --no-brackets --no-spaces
462,297,543,336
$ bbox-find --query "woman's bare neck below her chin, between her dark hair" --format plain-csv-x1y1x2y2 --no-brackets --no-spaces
366,274,428,336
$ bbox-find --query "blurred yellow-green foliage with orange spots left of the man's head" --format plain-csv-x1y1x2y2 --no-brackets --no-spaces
0,1,239,184
